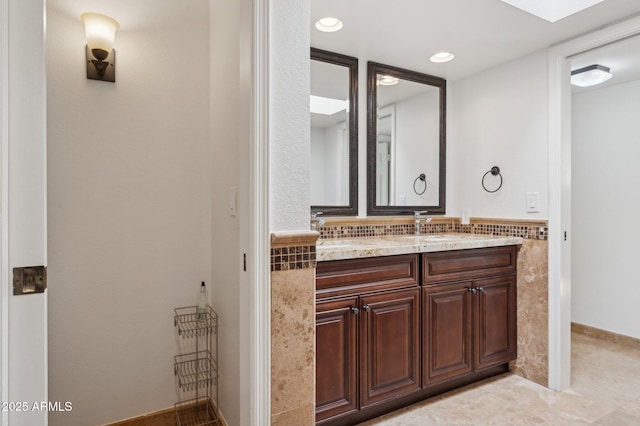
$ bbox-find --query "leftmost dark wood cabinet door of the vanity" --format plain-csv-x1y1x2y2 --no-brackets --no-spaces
316,297,358,422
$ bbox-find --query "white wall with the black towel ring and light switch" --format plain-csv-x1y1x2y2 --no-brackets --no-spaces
447,51,548,219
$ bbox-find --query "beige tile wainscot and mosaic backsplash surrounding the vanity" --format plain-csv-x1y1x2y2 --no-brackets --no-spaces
271,218,548,425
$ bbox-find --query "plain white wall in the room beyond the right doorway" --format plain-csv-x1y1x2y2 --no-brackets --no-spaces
571,81,640,338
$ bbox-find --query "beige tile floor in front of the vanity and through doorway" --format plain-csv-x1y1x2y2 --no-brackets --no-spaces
362,333,640,426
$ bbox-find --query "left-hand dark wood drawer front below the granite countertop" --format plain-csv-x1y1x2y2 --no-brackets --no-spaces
316,254,418,298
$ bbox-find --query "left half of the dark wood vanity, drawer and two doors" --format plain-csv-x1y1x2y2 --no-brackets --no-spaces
316,255,420,424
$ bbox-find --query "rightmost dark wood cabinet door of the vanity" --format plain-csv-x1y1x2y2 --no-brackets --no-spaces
475,275,516,370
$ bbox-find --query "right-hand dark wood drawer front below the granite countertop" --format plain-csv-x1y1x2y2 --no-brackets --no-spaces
422,246,517,284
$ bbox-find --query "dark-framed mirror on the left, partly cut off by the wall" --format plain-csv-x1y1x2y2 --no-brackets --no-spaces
310,48,358,216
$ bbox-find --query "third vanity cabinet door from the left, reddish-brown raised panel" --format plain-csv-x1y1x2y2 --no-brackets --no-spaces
422,281,474,386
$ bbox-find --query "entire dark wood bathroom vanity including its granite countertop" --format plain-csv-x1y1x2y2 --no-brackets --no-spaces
316,234,522,425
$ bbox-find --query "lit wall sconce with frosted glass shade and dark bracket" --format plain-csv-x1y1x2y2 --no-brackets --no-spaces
80,13,120,82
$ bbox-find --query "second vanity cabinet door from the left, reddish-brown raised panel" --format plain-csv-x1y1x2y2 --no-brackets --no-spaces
360,288,420,408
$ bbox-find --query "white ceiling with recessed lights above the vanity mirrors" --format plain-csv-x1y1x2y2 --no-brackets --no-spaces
309,0,640,81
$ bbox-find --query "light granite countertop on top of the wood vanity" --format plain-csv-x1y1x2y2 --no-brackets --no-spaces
316,233,522,262
